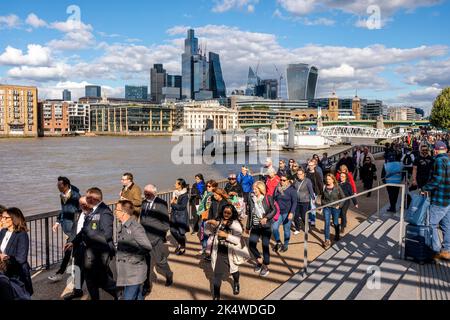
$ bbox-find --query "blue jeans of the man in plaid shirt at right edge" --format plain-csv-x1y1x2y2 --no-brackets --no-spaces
430,205,450,252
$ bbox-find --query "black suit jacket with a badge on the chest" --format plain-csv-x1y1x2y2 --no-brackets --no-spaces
72,202,115,256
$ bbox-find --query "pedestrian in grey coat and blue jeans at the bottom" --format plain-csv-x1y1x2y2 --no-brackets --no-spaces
115,200,152,300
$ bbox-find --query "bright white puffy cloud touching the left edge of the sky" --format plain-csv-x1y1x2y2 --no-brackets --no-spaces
0,44,51,66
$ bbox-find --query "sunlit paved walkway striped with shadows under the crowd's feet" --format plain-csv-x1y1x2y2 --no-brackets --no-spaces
33,162,387,300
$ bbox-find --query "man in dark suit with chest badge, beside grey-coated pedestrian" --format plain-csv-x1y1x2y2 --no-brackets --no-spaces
68,188,117,301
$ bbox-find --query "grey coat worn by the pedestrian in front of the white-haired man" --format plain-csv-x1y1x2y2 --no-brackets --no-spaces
116,218,152,287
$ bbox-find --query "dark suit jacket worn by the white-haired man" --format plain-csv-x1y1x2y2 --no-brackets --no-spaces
141,197,170,246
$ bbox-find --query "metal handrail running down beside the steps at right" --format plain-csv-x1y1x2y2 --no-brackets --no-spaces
303,183,406,275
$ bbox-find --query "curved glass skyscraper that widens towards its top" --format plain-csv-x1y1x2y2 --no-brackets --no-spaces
287,63,319,100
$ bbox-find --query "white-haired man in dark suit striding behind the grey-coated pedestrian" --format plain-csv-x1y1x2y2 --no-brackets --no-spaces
140,184,173,296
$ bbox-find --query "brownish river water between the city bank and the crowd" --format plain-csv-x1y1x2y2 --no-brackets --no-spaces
0,137,348,216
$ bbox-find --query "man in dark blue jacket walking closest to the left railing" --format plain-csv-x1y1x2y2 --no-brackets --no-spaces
48,177,80,282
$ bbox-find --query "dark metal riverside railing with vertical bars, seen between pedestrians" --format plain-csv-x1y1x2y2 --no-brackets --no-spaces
22,146,383,270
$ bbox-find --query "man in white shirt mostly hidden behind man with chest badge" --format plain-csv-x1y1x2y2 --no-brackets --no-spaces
63,197,92,301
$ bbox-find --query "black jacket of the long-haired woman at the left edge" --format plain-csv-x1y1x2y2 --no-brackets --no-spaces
0,229,33,295
